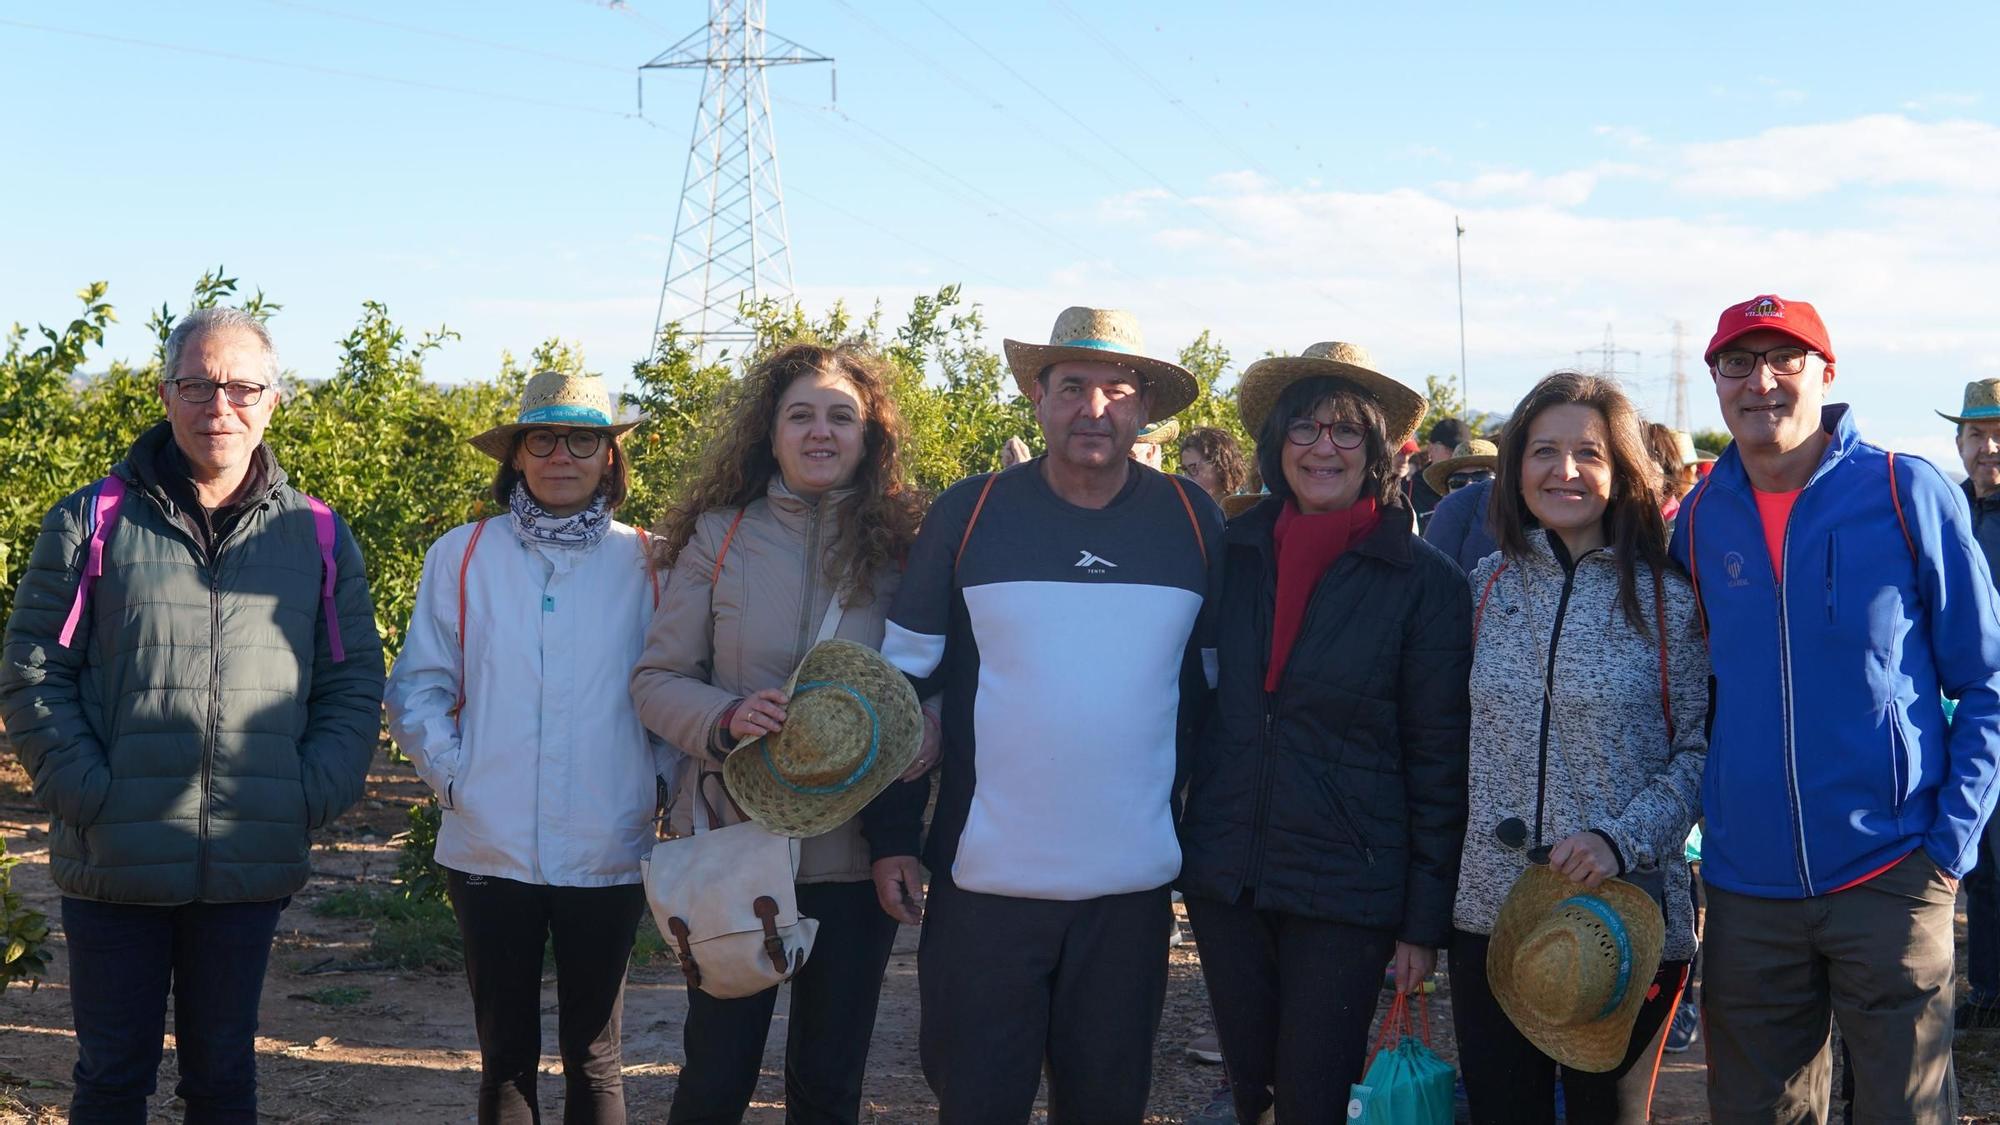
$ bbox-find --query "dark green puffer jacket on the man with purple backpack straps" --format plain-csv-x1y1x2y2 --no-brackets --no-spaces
0,422,384,905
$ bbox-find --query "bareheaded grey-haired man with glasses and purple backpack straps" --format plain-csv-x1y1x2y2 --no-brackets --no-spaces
0,308,382,1121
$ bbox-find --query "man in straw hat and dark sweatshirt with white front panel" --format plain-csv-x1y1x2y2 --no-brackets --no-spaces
864,308,1222,1125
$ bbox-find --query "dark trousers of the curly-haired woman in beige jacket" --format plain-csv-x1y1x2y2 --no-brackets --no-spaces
666,883,896,1125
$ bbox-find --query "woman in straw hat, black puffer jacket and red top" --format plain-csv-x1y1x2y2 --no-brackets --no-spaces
1178,344,1472,1125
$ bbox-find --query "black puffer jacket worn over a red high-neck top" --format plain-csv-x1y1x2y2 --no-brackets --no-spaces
1178,500,1472,947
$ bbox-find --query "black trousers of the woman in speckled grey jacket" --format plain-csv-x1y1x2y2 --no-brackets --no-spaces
1450,931,1688,1125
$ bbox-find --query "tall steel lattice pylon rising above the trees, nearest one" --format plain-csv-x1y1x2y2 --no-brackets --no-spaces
640,0,832,352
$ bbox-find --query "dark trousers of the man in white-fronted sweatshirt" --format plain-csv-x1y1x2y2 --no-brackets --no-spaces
918,879,1174,1125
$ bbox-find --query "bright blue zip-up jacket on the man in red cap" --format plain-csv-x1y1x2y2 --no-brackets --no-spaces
1672,404,2000,899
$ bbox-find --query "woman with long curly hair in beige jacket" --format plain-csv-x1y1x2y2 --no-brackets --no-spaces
632,344,938,1125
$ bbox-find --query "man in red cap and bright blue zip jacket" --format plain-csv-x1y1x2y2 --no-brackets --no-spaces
1674,296,2000,1123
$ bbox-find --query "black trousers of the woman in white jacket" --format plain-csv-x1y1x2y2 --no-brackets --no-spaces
446,871,646,1125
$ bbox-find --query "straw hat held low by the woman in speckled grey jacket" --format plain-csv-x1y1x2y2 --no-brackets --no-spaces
1486,865,1666,1073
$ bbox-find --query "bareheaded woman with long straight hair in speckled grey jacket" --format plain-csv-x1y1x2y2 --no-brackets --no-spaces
1450,372,1708,1125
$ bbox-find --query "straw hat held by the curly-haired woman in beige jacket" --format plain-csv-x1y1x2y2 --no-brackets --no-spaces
722,641,924,839
